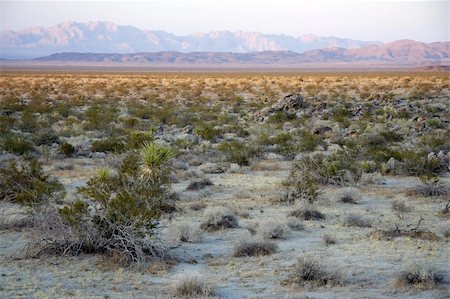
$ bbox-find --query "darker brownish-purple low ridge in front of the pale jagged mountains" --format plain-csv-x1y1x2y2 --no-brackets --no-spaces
34,40,450,66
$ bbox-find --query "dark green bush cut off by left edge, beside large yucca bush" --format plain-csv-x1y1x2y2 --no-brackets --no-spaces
0,159,65,206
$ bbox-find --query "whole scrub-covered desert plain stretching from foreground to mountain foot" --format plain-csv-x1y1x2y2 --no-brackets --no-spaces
0,71,450,298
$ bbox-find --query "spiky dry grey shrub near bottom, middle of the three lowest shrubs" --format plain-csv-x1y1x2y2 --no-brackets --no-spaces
286,256,344,287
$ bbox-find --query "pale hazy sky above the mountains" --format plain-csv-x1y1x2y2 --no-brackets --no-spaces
0,0,450,42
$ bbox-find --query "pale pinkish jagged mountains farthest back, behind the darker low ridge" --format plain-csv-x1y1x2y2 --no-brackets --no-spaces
0,22,382,59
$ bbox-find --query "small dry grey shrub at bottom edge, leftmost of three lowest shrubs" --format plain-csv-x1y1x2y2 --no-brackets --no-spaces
169,273,214,298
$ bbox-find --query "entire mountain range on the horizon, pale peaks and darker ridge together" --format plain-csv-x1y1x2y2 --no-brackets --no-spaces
0,22,450,66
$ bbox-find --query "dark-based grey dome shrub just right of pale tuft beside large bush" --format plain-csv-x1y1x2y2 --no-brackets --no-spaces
200,207,239,231
